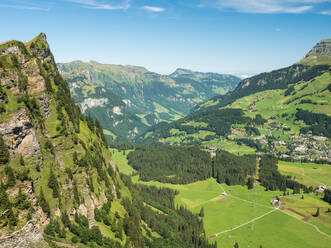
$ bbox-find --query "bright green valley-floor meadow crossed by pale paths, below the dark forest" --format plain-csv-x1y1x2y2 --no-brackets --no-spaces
113,152,331,248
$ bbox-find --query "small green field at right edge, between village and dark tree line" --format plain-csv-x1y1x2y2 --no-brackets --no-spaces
278,161,331,186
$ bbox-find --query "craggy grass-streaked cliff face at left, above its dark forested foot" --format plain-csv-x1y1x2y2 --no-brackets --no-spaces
0,34,122,247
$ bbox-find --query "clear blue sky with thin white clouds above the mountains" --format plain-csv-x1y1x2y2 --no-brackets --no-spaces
0,0,331,75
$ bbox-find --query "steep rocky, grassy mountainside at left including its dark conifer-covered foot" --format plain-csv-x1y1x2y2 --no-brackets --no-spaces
0,33,215,248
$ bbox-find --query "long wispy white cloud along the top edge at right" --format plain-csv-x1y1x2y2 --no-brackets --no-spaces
208,0,331,14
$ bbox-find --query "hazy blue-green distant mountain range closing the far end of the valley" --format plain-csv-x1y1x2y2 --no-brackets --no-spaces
58,61,239,141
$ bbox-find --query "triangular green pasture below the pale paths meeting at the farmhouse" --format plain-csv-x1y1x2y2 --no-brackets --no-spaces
212,210,331,248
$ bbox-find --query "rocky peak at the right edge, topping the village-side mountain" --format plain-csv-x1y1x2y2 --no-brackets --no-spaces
299,39,331,65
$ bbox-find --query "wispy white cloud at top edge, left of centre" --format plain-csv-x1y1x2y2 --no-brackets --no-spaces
67,0,130,10
